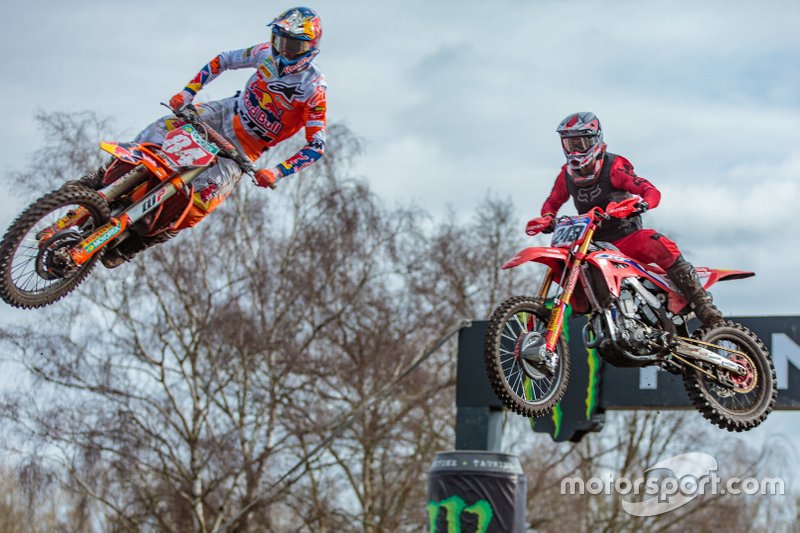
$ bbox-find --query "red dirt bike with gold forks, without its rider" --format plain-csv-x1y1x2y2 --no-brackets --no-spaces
484,197,777,431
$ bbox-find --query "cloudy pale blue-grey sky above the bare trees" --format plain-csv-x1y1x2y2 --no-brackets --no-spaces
0,0,800,470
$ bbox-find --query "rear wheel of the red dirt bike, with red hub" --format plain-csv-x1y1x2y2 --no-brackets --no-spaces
684,320,778,431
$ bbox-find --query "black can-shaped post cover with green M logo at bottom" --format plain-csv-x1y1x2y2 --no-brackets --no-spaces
428,451,527,533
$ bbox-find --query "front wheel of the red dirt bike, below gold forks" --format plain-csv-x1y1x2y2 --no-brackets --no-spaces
484,296,569,417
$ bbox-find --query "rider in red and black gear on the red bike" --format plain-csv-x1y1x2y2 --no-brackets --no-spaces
526,113,723,326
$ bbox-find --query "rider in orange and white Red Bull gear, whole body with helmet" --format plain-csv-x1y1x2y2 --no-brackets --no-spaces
102,7,327,268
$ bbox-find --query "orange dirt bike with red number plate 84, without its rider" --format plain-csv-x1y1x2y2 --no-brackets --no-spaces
0,106,272,308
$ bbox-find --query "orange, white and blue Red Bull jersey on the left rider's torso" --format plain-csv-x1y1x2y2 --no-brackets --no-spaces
186,43,327,176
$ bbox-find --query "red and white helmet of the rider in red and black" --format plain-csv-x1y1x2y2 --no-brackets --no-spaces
556,112,606,187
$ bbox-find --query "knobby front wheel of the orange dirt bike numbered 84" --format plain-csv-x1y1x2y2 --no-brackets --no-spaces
0,184,109,309
